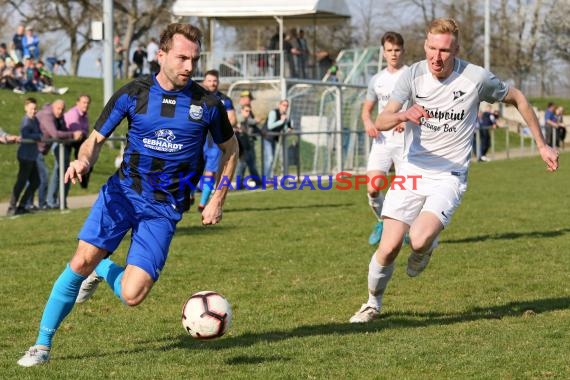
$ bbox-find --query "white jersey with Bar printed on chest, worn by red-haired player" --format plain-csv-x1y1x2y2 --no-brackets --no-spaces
391,58,509,175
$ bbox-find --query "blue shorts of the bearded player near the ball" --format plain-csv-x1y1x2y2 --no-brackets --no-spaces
78,176,182,281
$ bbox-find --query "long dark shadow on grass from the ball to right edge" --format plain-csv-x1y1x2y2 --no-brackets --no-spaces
163,297,570,352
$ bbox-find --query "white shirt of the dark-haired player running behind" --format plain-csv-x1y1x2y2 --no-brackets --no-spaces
366,66,408,145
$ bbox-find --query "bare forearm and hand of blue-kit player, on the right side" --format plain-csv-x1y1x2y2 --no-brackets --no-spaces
202,135,239,224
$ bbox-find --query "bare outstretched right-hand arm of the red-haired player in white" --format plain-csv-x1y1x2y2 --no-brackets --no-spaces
503,87,558,172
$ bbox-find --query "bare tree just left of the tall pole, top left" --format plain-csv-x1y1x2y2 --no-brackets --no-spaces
8,0,101,75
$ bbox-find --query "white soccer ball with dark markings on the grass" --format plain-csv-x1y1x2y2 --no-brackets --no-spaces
182,290,232,339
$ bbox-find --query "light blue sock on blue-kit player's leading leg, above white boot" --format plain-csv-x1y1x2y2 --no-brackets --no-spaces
36,264,86,347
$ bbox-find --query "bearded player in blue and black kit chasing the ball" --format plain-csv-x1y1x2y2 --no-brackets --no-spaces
18,23,238,367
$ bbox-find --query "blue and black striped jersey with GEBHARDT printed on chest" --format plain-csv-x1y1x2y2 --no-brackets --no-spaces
95,76,234,210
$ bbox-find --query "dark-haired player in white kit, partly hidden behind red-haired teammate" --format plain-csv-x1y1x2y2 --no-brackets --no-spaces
361,32,407,245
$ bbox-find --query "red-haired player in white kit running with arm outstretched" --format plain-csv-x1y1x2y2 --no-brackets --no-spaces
350,19,558,323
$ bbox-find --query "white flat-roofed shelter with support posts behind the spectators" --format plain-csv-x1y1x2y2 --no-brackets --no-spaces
172,0,350,96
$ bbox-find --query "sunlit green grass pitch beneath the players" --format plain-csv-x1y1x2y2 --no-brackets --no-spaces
0,153,570,379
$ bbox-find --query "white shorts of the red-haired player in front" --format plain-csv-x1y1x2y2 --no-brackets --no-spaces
382,170,467,227
